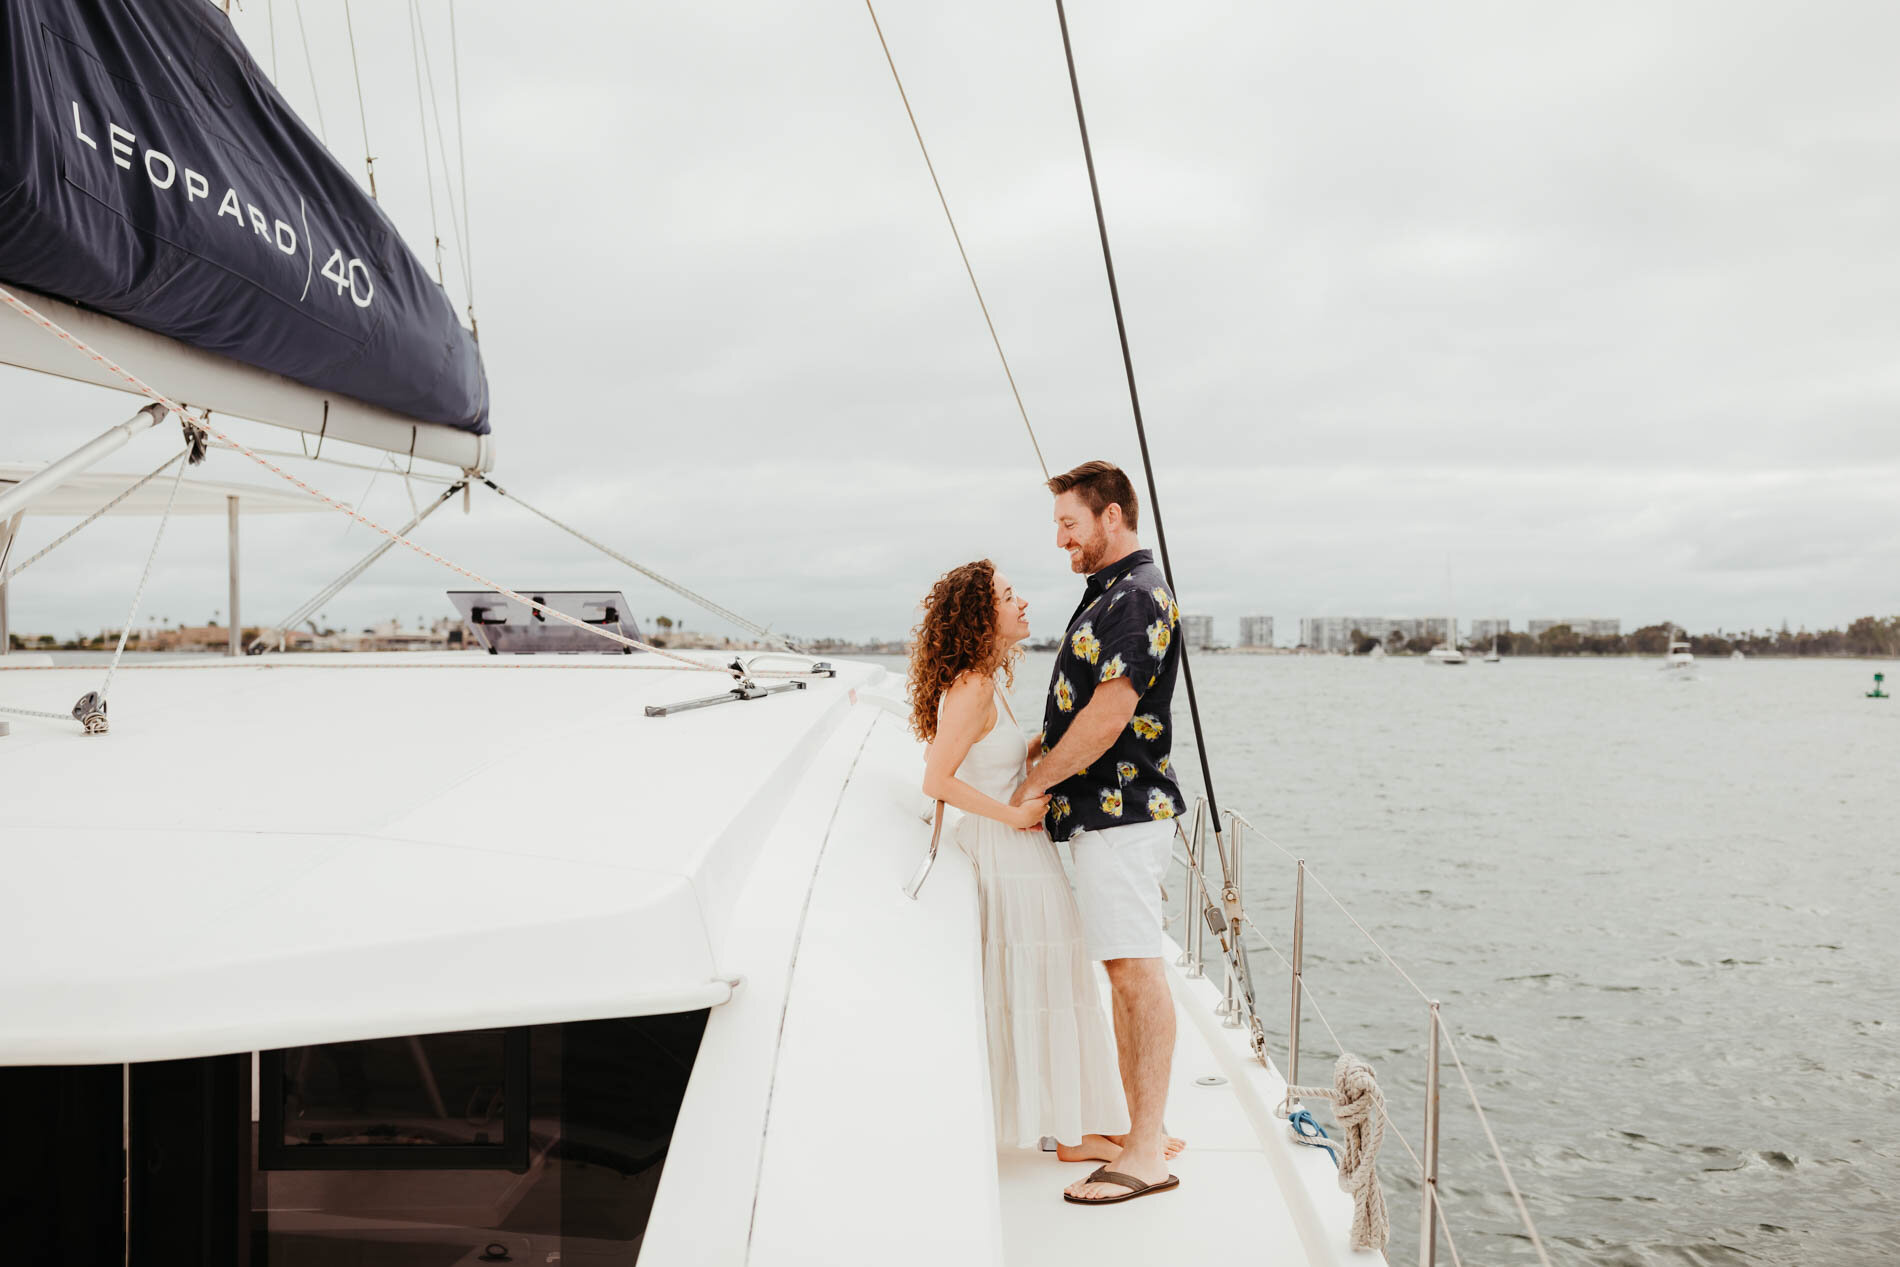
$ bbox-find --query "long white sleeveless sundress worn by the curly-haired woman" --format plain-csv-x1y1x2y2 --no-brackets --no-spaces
956,686,1129,1147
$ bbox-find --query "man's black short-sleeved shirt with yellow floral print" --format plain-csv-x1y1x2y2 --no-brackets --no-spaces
1043,549,1182,840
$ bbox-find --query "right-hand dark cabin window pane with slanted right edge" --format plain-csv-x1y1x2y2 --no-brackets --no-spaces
251,1011,707,1267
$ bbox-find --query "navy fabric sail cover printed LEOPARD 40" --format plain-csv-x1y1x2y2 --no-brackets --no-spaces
0,0,488,433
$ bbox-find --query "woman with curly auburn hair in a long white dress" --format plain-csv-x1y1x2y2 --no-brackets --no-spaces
910,558,1129,1161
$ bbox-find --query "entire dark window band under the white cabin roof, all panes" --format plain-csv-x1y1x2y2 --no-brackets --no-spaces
0,1011,707,1267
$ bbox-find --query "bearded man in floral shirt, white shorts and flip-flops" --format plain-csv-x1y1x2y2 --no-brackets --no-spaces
1011,462,1182,1204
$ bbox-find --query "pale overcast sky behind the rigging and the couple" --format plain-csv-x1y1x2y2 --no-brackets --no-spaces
0,0,1900,644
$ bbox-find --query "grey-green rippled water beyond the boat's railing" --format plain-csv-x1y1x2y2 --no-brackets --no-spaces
980,655,1900,1265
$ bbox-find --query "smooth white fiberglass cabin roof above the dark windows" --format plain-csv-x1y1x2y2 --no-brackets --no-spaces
0,653,882,1064
